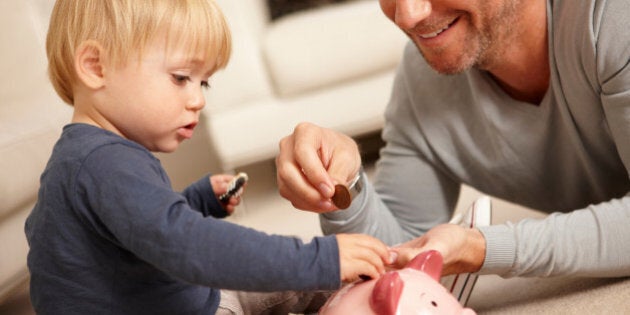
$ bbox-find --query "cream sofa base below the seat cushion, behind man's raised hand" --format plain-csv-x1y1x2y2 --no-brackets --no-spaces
203,69,394,171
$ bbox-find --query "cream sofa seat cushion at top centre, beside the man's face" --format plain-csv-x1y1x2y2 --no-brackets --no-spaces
263,0,407,96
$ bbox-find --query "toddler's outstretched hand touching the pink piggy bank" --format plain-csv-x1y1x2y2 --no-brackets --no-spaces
337,234,391,282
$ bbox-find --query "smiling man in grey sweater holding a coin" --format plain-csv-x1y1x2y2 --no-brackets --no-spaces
276,0,630,277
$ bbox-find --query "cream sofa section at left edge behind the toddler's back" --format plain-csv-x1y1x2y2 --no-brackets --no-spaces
0,0,71,299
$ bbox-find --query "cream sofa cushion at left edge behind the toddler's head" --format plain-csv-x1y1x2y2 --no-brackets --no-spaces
0,1,70,218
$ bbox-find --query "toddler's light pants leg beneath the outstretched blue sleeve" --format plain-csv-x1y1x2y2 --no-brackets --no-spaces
217,290,333,315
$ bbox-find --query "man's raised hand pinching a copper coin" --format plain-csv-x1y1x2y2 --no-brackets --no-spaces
276,123,361,213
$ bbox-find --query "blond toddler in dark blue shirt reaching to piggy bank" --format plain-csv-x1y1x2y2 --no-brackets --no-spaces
25,0,389,314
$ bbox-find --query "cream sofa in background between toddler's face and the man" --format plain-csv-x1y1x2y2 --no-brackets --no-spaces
204,0,407,171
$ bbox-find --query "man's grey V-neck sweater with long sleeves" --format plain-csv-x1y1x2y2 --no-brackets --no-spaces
321,0,630,277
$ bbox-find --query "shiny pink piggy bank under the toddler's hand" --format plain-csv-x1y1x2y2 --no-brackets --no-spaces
319,250,476,315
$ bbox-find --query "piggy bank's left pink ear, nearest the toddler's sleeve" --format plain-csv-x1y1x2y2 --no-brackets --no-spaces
370,271,404,315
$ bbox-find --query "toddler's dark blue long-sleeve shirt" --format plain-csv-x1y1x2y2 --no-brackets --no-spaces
25,124,340,314
